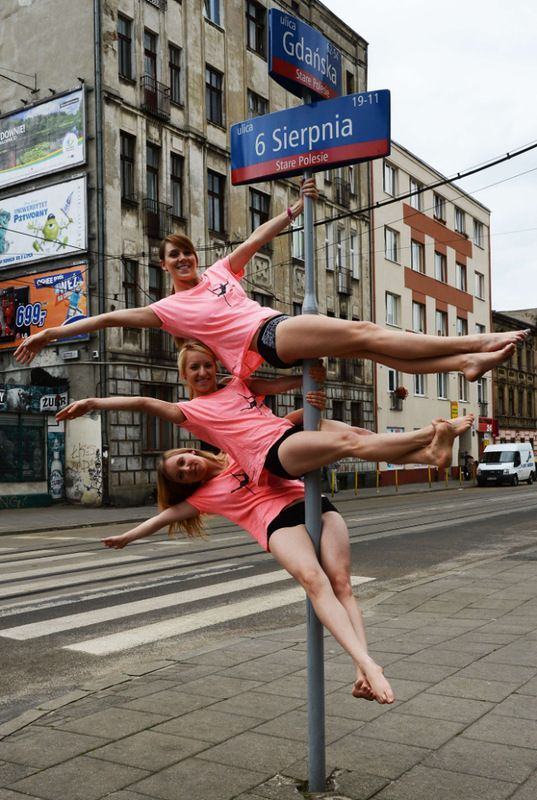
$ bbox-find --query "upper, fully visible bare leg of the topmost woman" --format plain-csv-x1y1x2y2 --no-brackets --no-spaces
276,314,528,363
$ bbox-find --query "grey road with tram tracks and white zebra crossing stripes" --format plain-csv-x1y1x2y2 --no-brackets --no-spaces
0,486,537,722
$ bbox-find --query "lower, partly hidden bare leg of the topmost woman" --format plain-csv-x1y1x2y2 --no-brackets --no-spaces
359,344,515,381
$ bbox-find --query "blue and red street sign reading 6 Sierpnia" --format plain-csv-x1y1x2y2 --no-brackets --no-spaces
231,89,390,185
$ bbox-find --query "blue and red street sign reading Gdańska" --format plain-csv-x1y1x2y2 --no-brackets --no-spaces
269,8,341,100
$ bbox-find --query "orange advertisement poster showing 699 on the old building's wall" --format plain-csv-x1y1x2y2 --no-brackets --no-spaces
0,263,88,350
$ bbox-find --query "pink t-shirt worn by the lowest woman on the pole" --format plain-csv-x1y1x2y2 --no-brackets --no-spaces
186,461,304,550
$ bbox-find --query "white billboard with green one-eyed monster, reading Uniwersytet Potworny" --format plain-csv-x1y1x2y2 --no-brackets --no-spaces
0,177,87,269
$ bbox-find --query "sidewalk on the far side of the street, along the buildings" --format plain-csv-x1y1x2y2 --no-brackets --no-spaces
0,480,473,536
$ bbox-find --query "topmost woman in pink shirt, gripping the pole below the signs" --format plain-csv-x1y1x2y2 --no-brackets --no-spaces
15,179,528,381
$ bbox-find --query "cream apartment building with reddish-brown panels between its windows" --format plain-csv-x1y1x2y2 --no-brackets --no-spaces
371,142,493,481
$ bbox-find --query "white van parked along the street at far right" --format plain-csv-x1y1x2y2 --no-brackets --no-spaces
477,442,535,486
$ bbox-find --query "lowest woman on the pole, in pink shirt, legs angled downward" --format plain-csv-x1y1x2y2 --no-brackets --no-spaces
102,449,395,703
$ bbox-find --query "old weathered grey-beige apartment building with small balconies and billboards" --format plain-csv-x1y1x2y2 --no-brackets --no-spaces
0,0,374,505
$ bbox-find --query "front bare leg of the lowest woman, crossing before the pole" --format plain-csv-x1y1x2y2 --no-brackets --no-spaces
270,525,395,703
